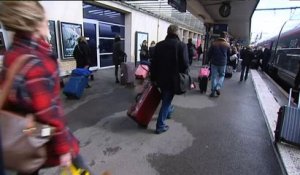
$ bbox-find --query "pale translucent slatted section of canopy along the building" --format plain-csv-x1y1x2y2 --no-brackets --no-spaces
122,0,205,34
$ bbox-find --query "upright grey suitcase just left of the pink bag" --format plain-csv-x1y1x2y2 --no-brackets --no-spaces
120,62,135,85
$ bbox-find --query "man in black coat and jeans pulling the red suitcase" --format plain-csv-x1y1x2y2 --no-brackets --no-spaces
150,25,189,134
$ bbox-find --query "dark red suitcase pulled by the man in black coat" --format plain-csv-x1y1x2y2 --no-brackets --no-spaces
127,82,161,128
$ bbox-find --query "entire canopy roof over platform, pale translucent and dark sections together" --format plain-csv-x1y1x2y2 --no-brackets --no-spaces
121,0,259,43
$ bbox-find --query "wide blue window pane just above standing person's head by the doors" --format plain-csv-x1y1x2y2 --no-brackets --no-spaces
99,23,125,38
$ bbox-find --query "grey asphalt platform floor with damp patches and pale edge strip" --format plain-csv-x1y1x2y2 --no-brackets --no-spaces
37,62,300,175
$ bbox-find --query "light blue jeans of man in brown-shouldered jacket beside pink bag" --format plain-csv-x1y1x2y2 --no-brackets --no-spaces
211,64,226,93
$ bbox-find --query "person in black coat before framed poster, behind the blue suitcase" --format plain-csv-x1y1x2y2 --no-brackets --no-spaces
73,36,91,68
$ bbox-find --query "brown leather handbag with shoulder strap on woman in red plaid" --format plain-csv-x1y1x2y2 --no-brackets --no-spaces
0,55,54,173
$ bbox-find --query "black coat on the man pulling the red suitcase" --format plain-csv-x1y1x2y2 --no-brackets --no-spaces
150,35,189,91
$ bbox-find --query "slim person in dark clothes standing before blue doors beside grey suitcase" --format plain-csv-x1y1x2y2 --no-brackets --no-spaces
113,35,127,83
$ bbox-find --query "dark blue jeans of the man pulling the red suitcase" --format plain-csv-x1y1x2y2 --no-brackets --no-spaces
156,90,174,130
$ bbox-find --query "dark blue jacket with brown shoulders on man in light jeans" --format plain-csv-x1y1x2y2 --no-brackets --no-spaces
208,38,230,66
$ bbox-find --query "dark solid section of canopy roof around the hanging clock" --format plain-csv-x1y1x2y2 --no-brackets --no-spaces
187,0,259,43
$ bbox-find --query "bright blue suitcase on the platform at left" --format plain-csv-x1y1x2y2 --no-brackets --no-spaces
63,75,88,99
